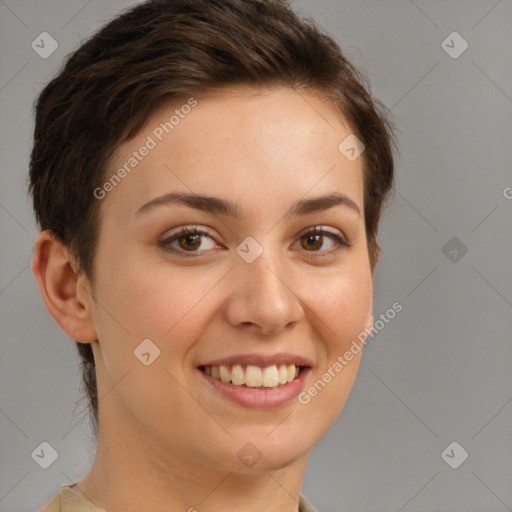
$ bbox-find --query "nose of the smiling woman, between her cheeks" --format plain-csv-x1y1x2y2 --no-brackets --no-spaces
225,247,303,336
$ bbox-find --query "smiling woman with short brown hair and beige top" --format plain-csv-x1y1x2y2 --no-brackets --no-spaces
29,0,394,512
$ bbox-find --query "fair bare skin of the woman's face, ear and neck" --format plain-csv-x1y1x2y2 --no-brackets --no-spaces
32,86,373,512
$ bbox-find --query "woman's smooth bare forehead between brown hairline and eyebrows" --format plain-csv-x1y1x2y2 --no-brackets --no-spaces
102,86,363,223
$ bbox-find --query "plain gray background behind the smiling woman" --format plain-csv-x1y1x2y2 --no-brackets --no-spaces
0,0,512,512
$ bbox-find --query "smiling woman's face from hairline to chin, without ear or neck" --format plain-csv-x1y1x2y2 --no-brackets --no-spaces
85,87,372,472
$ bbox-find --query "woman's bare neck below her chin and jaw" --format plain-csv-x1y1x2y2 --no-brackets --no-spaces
73,414,308,512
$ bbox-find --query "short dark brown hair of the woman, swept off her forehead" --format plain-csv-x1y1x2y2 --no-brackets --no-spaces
29,0,397,438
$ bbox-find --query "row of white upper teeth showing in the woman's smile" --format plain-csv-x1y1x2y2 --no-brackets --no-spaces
202,364,299,388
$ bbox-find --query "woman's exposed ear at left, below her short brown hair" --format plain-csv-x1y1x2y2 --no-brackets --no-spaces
32,230,97,343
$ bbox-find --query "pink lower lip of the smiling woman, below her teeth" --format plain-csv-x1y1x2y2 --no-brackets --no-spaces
197,367,311,409
